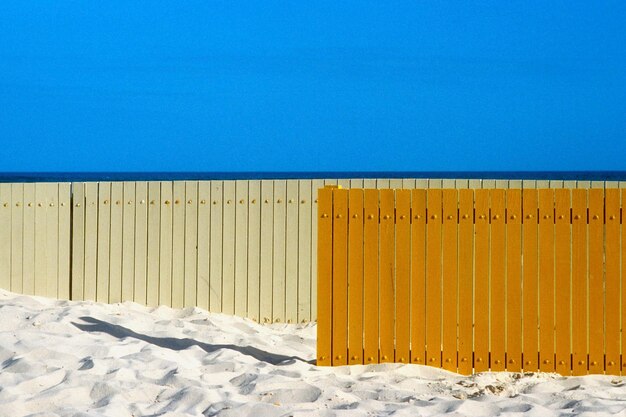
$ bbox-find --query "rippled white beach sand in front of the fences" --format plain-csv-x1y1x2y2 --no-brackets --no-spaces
0,290,626,417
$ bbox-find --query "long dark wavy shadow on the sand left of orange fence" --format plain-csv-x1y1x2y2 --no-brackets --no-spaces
72,317,315,365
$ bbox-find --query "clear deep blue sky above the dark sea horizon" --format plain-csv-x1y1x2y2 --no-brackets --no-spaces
0,0,626,172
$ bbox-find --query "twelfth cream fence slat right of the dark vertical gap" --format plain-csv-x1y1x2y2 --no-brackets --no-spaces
209,181,224,313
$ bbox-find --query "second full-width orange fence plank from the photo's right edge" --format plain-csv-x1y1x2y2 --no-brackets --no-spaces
589,188,604,374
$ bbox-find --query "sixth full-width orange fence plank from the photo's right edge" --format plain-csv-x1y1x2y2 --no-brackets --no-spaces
522,188,539,372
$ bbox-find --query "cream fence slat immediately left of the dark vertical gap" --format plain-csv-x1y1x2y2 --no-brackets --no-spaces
57,182,72,300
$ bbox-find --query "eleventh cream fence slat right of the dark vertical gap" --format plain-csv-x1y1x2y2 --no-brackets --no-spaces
196,181,212,310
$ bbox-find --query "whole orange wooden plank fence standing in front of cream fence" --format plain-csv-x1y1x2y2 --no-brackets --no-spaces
317,188,626,375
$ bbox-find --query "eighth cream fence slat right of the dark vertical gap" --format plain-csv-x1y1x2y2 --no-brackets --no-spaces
159,181,174,307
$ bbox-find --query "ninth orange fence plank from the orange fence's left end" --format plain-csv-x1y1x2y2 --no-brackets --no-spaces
442,188,459,372
